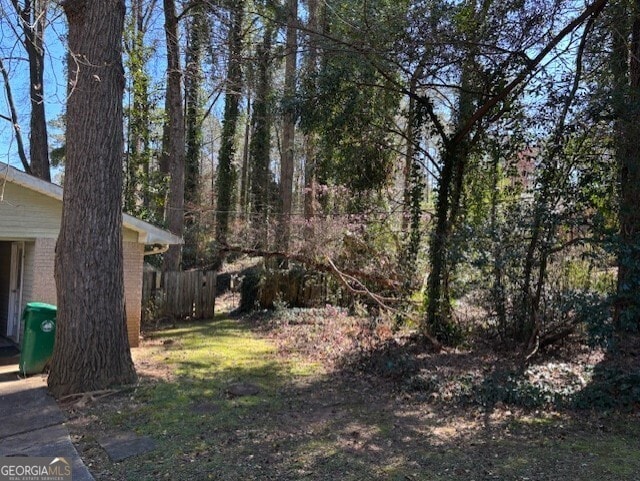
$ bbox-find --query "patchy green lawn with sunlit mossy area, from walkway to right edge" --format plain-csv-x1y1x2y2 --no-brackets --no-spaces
67,310,640,481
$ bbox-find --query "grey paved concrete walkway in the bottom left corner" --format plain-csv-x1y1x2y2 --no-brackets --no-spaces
0,365,94,481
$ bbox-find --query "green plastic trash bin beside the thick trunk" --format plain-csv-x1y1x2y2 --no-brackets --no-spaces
18,302,57,376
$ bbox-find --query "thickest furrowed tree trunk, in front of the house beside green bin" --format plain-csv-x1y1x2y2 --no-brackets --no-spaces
48,0,136,397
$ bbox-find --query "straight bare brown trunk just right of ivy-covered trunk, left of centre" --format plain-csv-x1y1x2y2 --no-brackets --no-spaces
278,0,298,252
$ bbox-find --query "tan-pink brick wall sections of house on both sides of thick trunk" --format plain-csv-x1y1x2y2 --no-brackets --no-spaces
30,239,144,347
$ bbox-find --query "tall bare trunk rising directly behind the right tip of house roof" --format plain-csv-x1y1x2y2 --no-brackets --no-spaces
163,0,185,271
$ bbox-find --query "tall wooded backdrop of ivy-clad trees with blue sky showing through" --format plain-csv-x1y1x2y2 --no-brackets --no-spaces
0,0,640,400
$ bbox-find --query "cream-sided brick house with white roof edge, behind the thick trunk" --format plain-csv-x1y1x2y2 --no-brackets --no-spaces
0,162,182,347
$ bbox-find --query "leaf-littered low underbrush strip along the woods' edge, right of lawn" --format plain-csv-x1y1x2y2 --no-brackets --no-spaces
252,306,640,410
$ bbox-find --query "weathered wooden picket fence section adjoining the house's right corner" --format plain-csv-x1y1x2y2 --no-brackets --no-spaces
142,270,216,321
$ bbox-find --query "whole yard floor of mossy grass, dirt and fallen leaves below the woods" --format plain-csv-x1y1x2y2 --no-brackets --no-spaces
65,299,640,481
